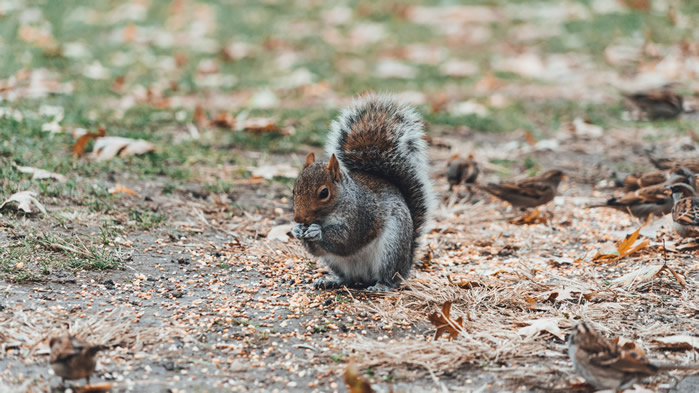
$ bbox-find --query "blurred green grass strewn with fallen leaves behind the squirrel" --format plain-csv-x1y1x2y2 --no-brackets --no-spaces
0,0,699,178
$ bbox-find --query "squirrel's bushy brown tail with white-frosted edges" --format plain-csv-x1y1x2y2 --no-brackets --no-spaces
326,94,435,238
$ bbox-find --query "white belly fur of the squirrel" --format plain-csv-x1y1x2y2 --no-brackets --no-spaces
320,217,398,282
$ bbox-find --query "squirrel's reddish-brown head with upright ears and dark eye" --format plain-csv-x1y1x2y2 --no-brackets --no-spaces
294,153,342,224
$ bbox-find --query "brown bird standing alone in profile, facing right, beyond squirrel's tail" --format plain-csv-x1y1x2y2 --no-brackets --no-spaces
481,169,565,208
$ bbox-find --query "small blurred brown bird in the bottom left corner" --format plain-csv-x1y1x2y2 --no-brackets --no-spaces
49,335,108,385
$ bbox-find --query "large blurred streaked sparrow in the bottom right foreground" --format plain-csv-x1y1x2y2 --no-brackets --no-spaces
568,322,659,390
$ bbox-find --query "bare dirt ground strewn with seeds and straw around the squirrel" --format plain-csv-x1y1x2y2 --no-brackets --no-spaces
0,124,699,392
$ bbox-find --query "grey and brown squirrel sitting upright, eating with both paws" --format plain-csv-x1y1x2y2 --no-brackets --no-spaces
292,94,436,291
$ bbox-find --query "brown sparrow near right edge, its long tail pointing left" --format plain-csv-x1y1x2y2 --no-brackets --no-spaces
590,168,696,220
